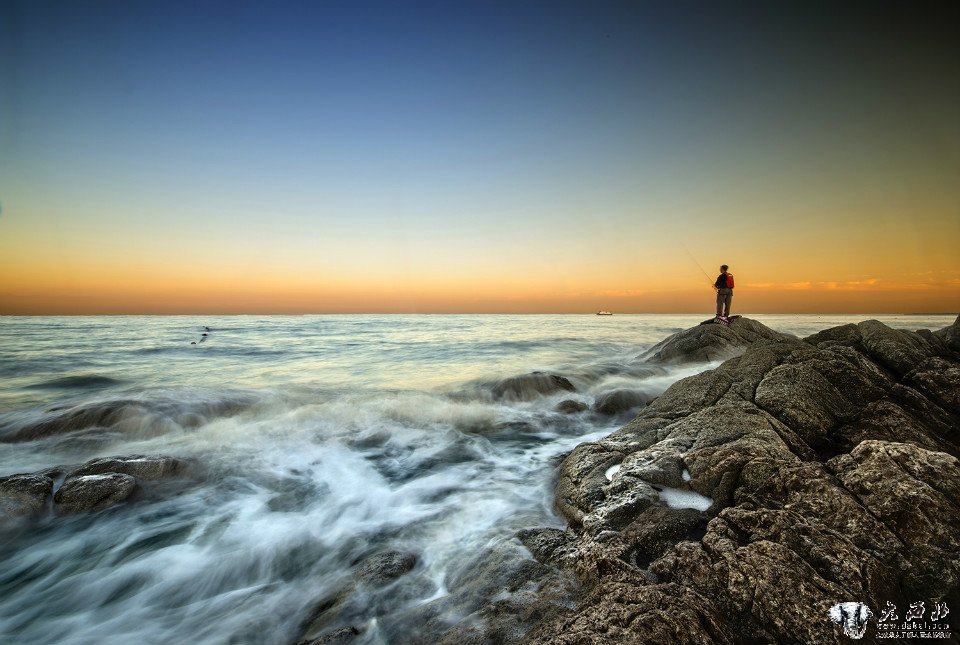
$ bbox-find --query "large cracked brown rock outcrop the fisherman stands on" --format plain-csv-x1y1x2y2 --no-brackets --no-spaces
519,318,960,643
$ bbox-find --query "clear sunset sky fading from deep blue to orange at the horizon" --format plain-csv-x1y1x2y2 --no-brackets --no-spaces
0,0,960,314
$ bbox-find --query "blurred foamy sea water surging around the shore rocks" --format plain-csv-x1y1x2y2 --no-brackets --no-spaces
0,315,954,644
